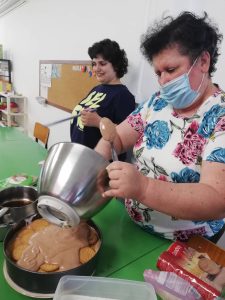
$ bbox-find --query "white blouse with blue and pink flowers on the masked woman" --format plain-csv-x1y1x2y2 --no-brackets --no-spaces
125,91,225,240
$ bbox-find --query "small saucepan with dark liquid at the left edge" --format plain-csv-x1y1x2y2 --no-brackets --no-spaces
0,186,38,240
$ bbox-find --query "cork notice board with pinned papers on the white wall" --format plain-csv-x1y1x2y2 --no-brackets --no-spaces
39,60,98,112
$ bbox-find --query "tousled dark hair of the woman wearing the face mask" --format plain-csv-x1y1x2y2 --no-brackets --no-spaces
141,11,223,77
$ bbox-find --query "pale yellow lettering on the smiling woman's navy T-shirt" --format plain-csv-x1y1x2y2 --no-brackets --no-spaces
71,91,106,131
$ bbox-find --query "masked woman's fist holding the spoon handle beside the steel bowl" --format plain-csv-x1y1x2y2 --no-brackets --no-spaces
102,161,148,199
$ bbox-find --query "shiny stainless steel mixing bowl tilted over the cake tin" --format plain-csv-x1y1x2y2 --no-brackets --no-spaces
37,142,109,226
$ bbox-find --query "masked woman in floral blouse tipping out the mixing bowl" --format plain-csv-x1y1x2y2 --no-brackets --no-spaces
96,12,225,241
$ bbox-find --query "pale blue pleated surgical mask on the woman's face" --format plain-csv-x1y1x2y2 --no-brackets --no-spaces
160,58,205,109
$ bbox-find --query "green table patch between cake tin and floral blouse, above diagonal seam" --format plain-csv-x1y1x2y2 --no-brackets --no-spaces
93,200,168,280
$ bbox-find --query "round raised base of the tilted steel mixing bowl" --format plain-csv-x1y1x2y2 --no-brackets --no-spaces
37,195,80,227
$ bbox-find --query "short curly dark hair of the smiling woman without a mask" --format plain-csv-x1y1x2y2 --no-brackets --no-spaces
88,39,128,78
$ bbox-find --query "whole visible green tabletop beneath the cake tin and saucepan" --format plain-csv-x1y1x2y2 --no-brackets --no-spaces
0,128,170,300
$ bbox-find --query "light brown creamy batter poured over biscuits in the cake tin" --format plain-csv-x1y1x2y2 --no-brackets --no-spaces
17,223,90,271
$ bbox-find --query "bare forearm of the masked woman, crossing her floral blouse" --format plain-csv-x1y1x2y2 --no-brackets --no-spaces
141,178,225,220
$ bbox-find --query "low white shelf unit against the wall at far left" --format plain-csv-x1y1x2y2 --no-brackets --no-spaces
0,93,27,132
